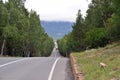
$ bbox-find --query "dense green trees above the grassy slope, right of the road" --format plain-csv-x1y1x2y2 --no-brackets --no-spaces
58,0,120,56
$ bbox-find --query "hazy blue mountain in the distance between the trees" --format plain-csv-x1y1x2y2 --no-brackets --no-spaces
41,21,73,39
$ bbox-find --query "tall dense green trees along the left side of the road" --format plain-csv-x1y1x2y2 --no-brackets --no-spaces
0,0,54,57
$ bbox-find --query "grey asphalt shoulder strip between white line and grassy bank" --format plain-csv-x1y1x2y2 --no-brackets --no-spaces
52,58,73,80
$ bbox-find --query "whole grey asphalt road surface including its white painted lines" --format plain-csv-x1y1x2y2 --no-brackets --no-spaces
0,48,73,80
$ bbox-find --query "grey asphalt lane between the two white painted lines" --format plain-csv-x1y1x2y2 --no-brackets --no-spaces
0,58,56,80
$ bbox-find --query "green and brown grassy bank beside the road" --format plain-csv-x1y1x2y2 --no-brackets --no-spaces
72,42,120,80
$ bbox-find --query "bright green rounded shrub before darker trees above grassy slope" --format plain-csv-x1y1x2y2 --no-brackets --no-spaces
85,28,108,48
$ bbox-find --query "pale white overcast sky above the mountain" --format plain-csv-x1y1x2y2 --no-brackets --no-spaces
3,0,91,22
